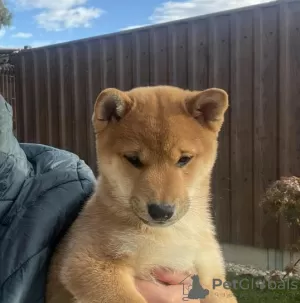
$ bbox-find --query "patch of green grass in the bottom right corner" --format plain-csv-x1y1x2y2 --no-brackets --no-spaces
227,273,300,303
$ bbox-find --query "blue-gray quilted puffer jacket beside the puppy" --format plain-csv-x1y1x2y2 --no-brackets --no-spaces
0,95,95,303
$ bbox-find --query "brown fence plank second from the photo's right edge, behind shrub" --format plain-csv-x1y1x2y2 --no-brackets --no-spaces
253,7,279,247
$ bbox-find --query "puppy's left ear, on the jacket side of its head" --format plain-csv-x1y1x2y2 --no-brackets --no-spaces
92,88,132,126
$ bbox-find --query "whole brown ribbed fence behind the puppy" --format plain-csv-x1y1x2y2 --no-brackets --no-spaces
10,1,300,248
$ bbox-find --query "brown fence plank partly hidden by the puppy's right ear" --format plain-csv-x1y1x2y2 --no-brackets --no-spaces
209,15,231,243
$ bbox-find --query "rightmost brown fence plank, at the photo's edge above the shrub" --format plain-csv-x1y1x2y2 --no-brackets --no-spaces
281,2,300,247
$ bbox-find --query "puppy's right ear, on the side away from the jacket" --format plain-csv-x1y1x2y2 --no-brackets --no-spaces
185,88,228,133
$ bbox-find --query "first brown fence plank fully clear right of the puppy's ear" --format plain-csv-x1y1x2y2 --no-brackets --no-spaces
231,11,254,245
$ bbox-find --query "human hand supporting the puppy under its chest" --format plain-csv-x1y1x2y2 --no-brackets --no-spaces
136,269,192,303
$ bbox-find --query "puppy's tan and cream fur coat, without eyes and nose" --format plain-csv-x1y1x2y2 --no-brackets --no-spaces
47,86,237,303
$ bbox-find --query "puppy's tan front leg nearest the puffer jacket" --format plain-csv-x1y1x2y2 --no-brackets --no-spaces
60,255,146,303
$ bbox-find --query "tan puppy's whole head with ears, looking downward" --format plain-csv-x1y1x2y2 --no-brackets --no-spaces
93,86,228,226
